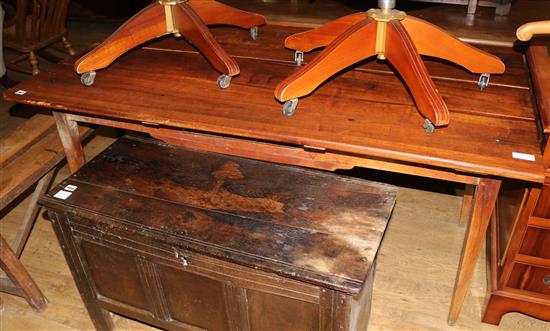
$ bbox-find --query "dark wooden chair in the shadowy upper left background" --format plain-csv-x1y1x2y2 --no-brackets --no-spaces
4,0,75,75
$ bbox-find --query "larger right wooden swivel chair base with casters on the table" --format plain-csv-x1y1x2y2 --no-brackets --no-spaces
275,0,505,132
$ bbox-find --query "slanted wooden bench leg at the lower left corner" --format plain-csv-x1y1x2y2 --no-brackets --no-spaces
0,235,48,311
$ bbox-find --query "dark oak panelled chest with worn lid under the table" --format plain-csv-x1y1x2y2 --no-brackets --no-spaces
40,137,396,330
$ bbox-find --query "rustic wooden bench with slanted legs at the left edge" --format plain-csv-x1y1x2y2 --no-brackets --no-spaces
0,114,91,310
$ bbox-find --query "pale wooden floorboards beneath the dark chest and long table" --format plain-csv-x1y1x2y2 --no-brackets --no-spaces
0,129,547,331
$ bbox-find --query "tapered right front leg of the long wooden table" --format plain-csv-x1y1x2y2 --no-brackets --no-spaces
447,178,501,325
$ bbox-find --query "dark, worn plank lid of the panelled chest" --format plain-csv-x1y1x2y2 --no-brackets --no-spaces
41,137,397,293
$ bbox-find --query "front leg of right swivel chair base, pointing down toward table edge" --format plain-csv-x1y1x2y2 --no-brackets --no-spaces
385,21,449,126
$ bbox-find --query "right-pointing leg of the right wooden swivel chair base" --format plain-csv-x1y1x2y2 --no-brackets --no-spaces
402,16,505,74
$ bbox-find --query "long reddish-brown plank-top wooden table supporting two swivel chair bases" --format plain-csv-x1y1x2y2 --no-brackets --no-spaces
4,25,544,324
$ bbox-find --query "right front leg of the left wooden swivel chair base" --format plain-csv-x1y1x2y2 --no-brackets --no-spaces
174,3,240,76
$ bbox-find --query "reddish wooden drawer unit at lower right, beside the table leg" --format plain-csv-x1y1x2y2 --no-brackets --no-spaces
483,186,550,325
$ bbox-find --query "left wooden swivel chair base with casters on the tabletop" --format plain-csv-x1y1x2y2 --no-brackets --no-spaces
74,0,266,89
